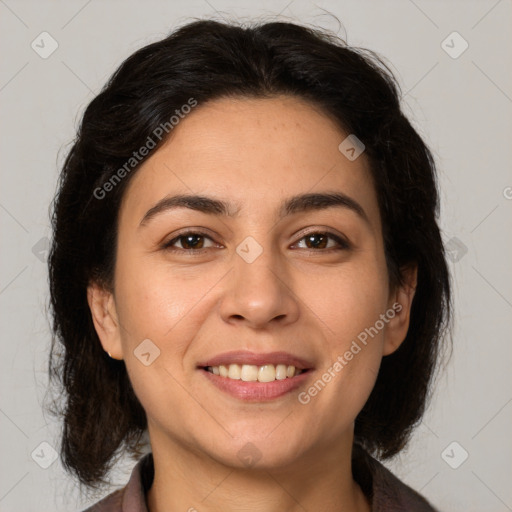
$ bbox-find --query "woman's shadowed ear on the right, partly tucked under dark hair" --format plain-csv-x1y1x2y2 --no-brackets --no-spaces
383,265,418,356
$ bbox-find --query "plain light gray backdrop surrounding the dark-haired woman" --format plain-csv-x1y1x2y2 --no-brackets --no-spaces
0,0,512,512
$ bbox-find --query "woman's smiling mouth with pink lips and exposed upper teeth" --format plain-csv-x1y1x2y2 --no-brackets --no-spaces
197,351,314,402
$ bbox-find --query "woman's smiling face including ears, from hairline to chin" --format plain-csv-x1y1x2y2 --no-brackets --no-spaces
90,97,412,467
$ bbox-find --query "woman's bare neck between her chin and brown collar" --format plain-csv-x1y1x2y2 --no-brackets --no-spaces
147,428,371,512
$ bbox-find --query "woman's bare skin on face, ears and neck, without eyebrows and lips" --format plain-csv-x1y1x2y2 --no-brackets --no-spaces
88,96,416,512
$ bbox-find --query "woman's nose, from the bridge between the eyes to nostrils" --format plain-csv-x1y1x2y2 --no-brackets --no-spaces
220,240,299,329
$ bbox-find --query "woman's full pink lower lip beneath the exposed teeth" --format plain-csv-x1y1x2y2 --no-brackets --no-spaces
200,369,311,402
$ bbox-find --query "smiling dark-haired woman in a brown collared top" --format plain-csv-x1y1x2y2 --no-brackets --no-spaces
49,17,450,512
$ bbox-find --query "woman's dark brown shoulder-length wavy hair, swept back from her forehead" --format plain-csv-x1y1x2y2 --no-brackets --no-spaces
45,20,451,494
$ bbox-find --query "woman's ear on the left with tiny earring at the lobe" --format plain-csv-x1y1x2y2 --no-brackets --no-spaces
87,282,123,360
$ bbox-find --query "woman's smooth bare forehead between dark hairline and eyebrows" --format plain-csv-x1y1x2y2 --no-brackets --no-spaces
118,96,378,227
